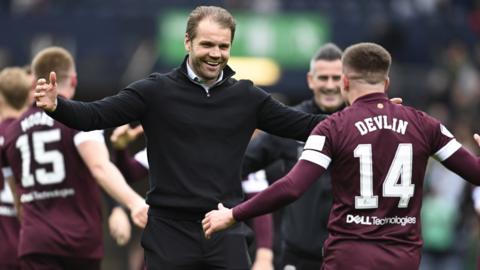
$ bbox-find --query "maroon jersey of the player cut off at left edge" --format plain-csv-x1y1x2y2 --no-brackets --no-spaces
0,119,20,268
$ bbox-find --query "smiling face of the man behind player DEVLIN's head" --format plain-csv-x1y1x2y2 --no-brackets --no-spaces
307,59,343,113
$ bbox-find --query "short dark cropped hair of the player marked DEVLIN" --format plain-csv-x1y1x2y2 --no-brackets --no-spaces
342,42,392,84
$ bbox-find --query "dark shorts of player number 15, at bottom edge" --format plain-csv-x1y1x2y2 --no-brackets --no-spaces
20,254,101,270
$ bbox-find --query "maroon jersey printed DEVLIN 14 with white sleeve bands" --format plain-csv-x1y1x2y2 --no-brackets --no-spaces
301,93,461,264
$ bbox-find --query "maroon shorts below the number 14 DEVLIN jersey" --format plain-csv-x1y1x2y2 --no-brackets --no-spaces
322,240,421,270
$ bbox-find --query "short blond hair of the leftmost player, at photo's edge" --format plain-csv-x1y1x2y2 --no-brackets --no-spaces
0,67,33,110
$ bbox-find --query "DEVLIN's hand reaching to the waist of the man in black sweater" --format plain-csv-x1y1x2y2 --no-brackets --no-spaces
202,203,235,239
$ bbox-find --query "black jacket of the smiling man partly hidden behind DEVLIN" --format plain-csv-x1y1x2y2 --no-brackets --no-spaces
242,99,344,260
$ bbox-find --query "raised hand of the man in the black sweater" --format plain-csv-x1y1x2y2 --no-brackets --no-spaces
33,71,58,112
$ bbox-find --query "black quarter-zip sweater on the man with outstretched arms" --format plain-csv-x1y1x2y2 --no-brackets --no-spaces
49,56,324,219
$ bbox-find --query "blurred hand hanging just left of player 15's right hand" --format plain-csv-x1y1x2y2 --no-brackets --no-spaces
108,206,132,246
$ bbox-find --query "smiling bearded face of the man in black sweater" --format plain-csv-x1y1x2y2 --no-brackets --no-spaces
185,17,232,85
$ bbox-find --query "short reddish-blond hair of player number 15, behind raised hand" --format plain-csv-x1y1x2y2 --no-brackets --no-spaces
31,47,75,83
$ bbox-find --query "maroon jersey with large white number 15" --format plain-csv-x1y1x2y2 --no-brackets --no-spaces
5,107,103,258
